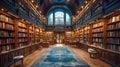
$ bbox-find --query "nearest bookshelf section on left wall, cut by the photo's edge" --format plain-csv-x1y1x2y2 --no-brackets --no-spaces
0,13,15,53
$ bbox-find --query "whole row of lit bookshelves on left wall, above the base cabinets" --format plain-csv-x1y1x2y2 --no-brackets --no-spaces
0,13,42,53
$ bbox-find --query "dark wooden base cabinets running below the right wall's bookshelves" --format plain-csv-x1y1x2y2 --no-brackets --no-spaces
77,43,120,67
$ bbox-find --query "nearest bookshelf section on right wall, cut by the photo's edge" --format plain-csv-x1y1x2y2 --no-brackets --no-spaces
107,14,120,51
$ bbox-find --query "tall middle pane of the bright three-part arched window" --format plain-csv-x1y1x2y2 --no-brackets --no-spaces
55,11,64,25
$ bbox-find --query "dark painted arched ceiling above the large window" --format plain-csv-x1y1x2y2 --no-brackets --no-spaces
34,0,86,15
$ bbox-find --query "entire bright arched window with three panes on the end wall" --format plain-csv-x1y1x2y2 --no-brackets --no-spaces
48,9,71,26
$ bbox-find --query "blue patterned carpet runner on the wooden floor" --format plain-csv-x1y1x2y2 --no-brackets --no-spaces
31,46,90,67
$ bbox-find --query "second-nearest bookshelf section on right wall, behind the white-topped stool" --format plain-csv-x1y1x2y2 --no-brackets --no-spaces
92,20,104,48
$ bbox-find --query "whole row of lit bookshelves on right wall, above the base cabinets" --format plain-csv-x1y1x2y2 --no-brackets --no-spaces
75,10,120,50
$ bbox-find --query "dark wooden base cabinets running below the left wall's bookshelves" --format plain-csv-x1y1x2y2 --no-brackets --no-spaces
0,43,40,67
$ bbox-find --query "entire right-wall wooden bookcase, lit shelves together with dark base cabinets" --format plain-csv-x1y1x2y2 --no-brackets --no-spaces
75,10,120,67
